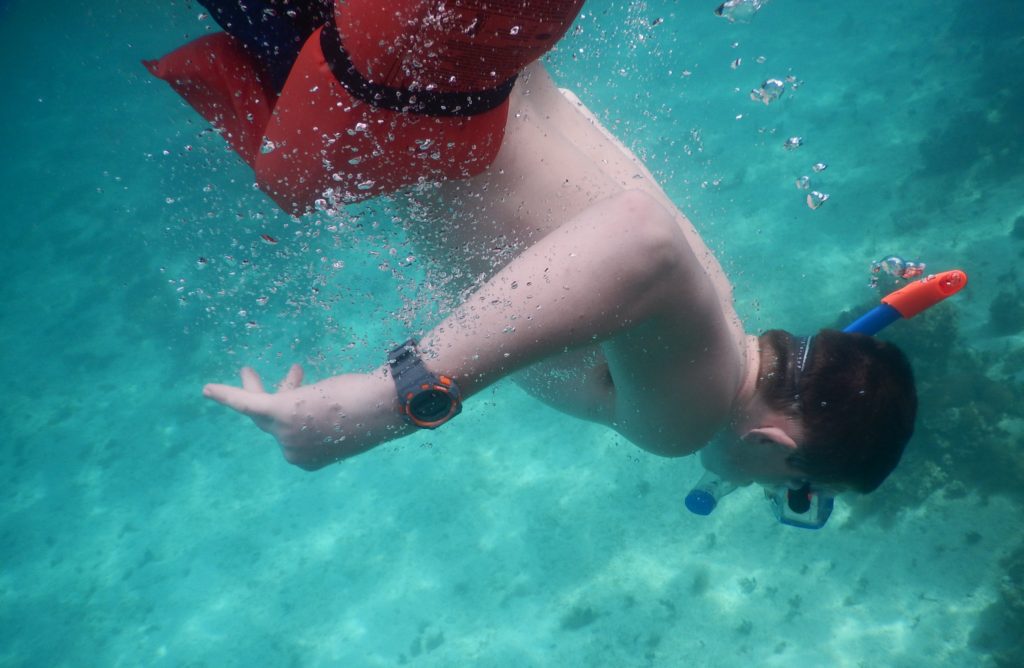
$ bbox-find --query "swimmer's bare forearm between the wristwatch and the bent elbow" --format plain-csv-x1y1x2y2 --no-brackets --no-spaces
420,187,714,396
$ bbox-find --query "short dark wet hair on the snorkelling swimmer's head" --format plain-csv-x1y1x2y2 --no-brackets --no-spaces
758,329,918,494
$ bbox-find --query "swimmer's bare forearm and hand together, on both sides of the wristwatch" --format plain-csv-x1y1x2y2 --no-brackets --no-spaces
203,193,709,470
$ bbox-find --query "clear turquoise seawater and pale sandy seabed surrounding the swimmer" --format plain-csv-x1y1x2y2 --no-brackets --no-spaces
0,0,1024,667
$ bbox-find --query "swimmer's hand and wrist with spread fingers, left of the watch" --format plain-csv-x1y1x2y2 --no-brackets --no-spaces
203,364,412,471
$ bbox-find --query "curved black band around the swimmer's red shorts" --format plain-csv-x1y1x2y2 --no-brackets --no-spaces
321,19,516,116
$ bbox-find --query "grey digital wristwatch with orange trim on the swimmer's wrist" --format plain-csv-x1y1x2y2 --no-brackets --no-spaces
387,339,462,429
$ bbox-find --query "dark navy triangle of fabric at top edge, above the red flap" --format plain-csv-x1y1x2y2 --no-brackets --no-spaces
199,0,334,93
